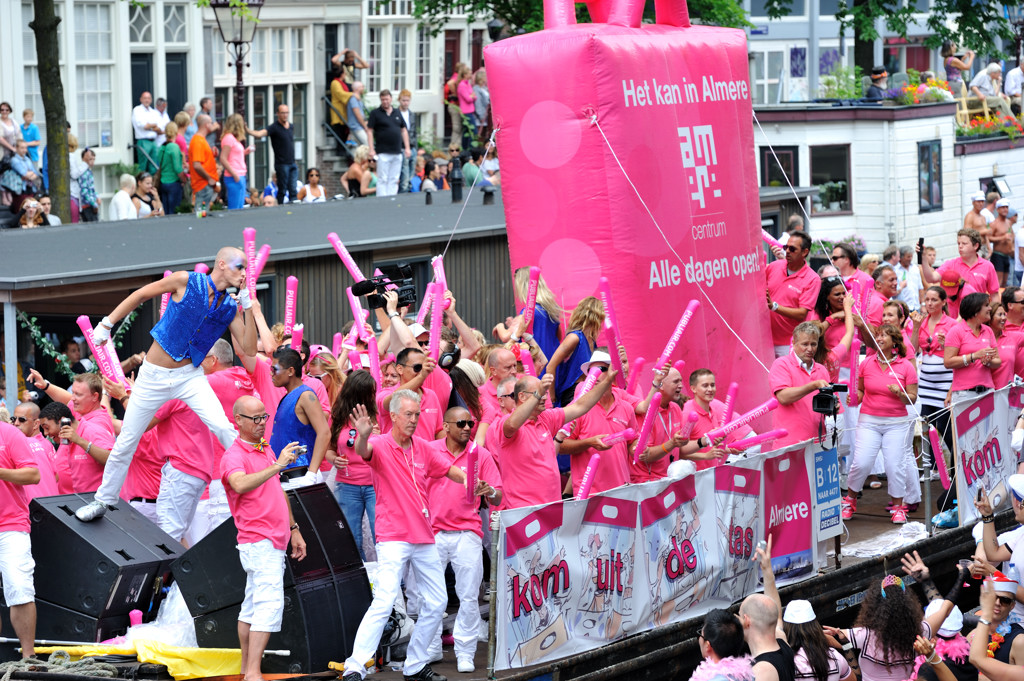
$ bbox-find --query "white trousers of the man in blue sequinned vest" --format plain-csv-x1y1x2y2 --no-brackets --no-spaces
96,361,239,506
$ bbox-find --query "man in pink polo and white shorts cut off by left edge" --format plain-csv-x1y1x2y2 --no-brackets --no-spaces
0,423,39,657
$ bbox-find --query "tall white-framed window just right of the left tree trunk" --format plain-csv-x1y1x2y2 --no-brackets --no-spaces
75,3,114,146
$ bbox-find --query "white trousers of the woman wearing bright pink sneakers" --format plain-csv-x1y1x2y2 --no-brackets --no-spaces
847,412,913,498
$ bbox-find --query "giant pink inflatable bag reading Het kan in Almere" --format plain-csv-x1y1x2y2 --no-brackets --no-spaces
485,0,771,411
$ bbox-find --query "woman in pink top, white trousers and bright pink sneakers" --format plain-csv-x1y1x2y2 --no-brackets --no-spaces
843,324,918,523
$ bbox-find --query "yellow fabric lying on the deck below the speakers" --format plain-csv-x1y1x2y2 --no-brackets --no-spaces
36,641,242,681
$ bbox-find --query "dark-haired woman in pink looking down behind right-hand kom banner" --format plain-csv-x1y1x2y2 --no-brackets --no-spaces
943,293,1001,402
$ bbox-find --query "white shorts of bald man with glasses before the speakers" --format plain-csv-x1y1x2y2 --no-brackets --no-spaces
239,539,285,633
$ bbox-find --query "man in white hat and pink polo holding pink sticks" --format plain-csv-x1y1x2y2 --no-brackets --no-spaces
558,348,639,495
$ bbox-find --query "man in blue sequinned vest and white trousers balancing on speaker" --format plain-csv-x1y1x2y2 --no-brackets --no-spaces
75,246,256,522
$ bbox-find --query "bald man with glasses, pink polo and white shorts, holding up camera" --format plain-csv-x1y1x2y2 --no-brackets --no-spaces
220,397,306,681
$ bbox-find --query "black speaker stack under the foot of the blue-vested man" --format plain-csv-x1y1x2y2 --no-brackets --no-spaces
0,495,184,656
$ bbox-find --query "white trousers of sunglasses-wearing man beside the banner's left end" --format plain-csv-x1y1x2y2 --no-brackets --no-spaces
427,530,483,659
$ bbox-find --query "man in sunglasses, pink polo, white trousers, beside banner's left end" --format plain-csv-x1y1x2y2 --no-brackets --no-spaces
427,407,502,673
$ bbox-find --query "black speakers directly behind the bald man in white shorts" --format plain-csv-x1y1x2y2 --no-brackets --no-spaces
171,484,372,674
